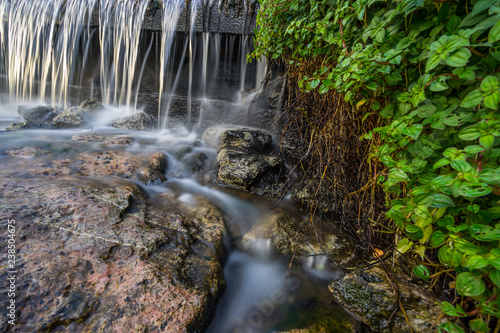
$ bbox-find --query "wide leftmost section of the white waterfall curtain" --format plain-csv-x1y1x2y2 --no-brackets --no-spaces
0,0,96,106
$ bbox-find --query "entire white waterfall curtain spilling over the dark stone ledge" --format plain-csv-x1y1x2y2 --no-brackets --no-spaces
0,0,265,131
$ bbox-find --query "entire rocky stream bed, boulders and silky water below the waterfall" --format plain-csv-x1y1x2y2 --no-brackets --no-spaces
0,100,460,333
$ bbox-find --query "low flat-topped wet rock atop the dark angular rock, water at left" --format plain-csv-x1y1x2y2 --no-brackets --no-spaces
202,125,272,151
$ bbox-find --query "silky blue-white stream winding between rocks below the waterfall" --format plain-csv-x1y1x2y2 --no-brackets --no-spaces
0,105,357,333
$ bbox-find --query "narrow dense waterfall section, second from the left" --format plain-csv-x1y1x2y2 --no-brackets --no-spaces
99,0,149,108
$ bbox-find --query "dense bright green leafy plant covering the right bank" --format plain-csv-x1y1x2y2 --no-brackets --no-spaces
252,0,500,332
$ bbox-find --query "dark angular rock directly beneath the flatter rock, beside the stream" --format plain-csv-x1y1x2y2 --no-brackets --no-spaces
217,148,282,189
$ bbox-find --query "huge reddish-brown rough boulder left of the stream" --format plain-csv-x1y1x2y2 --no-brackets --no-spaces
0,177,225,332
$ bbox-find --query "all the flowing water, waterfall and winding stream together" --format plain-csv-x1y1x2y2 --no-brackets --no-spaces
0,0,357,333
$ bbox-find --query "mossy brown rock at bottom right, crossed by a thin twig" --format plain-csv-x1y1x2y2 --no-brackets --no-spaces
329,264,458,333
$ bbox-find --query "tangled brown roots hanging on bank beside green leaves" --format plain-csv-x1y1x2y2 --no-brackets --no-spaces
281,71,384,245
